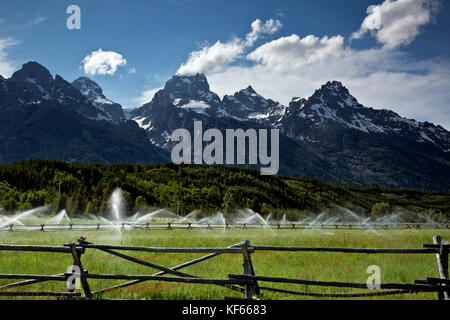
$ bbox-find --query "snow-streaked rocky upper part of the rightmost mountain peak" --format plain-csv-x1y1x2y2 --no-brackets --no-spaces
282,81,450,150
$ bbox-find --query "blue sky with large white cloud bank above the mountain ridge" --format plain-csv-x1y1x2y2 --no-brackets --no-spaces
0,0,450,129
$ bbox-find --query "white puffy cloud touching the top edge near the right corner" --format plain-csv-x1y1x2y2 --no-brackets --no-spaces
352,0,439,48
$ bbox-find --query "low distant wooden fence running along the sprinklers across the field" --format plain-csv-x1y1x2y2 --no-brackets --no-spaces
0,221,450,232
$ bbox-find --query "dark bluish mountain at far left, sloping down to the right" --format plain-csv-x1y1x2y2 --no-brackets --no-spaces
0,62,169,163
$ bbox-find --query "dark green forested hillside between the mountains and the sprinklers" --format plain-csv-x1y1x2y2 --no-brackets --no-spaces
0,160,450,218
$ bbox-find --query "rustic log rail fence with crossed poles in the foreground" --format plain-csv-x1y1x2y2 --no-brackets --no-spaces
0,236,450,300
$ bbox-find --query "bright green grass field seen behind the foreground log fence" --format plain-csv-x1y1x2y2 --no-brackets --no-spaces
0,230,450,300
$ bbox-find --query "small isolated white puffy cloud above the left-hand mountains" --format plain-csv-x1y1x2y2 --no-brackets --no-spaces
83,49,127,75
